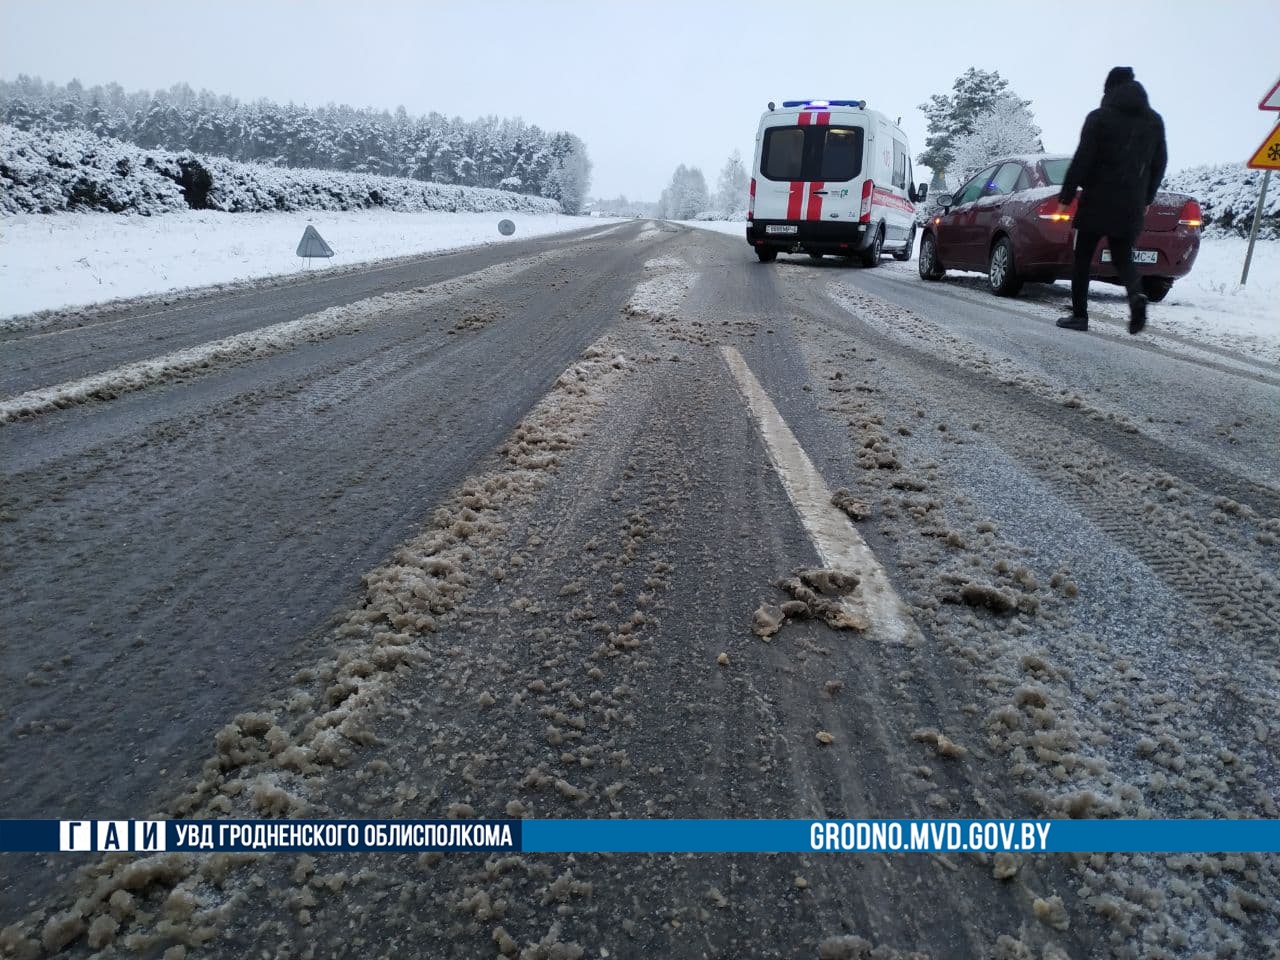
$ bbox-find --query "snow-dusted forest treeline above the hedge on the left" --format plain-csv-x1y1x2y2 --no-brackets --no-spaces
0,74,590,212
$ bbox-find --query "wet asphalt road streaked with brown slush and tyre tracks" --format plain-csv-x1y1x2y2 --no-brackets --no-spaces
0,223,1280,959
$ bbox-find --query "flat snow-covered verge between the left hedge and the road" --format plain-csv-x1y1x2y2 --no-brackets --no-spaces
0,210,623,316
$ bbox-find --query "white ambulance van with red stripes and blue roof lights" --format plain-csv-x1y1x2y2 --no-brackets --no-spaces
746,100,928,266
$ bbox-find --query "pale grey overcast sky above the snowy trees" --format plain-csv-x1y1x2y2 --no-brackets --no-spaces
0,0,1280,200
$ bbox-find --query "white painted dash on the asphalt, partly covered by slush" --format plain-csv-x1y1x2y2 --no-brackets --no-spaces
721,346,920,646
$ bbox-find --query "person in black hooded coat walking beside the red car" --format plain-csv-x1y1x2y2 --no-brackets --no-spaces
1057,67,1167,333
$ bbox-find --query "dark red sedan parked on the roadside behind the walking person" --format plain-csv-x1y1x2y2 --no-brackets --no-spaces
919,154,1201,301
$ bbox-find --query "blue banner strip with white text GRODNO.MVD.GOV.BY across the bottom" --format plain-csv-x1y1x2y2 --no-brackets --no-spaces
0,820,1280,854
